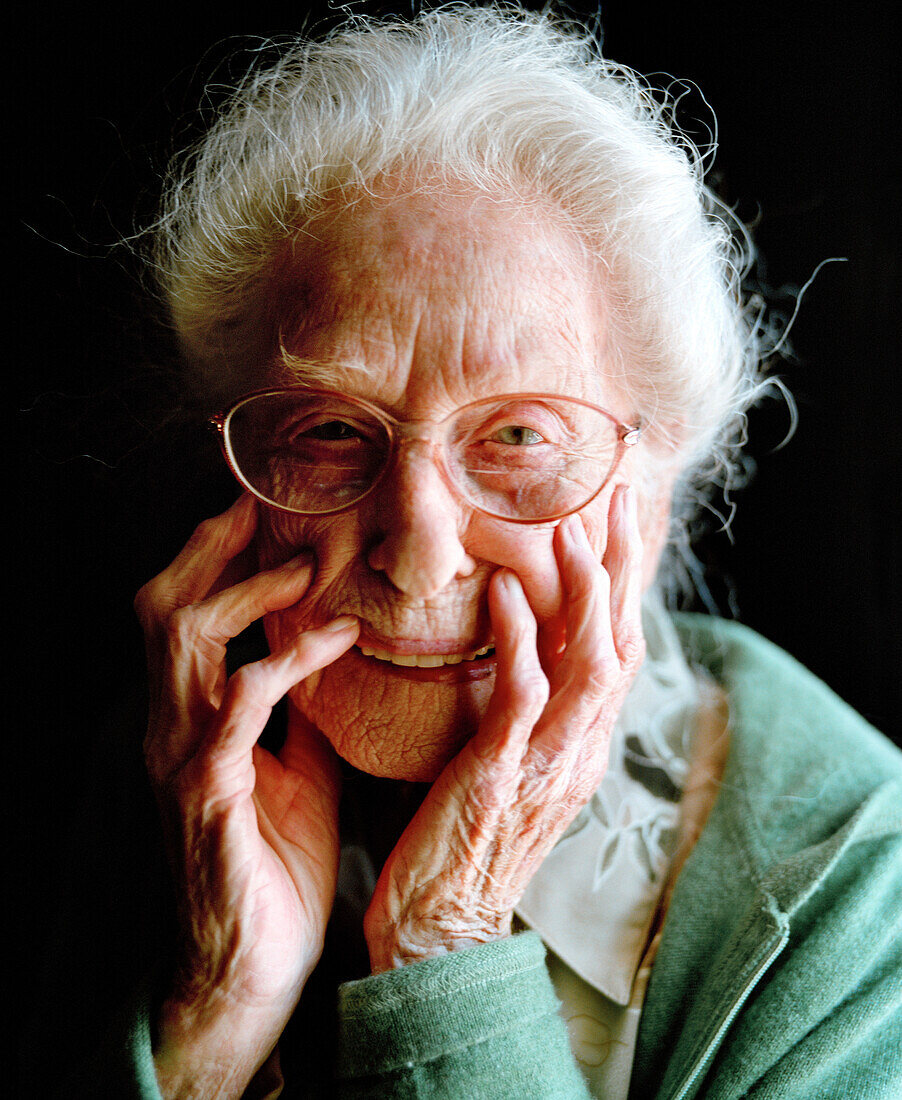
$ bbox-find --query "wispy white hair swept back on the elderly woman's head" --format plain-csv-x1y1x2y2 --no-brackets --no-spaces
149,4,783,602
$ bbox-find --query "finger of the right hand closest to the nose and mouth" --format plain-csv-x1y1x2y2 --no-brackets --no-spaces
471,569,549,763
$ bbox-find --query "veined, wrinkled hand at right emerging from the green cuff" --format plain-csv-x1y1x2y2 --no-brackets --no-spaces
364,486,645,974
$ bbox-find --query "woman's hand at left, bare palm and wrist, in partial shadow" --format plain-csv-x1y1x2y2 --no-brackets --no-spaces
135,495,359,1097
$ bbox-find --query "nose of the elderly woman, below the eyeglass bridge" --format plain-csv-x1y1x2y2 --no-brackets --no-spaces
367,441,476,600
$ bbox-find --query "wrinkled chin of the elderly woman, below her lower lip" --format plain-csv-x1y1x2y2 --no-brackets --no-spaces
292,652,494,783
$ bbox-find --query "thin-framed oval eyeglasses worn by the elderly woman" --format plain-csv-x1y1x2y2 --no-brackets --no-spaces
210,387,641,524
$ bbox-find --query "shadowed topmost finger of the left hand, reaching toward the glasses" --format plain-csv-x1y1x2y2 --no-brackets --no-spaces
135,493,257,630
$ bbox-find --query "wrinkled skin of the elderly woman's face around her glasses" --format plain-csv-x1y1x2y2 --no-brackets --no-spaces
260,189,664,780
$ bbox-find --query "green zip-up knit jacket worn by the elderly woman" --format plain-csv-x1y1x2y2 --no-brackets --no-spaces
86,615,902,1100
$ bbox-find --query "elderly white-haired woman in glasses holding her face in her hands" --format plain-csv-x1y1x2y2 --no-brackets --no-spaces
70,9,902,1100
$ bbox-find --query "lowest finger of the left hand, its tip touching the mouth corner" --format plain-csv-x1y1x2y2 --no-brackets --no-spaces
202,615,360,765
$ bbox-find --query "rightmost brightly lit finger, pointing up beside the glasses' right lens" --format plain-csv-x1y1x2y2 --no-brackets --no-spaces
604,485,645,668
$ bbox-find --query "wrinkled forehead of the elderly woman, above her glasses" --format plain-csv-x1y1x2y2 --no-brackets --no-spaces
267,187,604,407
